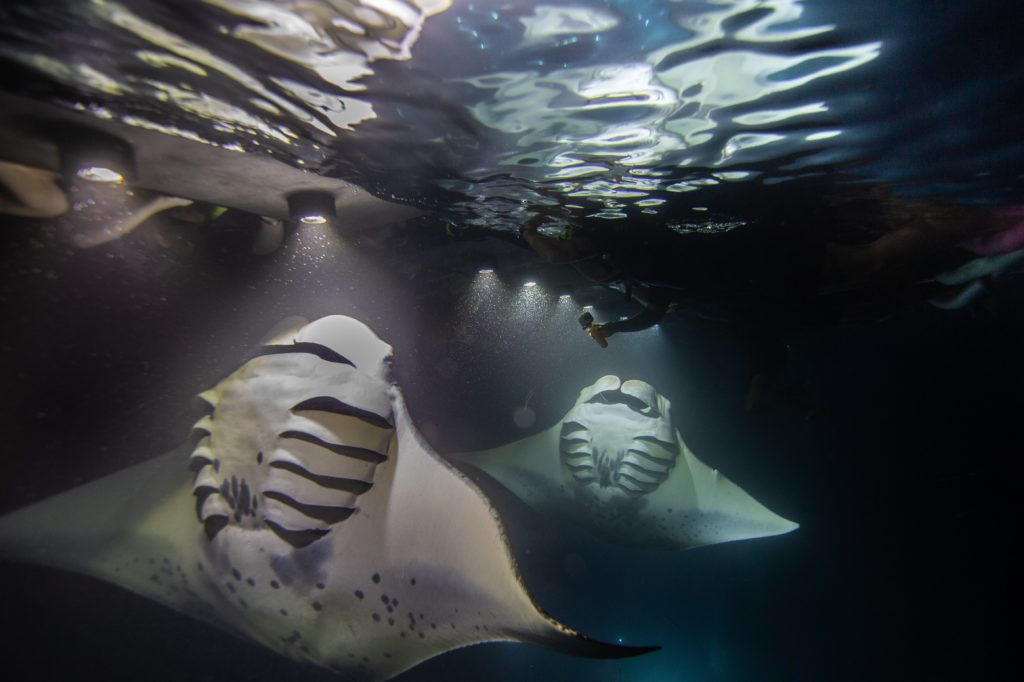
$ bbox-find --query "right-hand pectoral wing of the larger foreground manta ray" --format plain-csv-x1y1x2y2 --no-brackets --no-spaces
344,391,657,666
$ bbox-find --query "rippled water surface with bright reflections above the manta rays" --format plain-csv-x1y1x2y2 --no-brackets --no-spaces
0,0,1022,229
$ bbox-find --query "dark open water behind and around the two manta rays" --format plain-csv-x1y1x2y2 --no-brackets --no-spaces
0,205,1024,682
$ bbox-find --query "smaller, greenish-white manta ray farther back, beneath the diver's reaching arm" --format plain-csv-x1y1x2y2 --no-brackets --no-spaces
452,368,798,549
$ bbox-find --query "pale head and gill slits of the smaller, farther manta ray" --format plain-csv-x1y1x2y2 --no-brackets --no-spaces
559,376,679,496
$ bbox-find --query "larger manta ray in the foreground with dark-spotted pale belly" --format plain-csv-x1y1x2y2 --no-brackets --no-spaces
0,316,656,680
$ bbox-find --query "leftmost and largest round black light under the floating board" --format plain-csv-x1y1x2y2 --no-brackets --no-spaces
58,127,135,184
